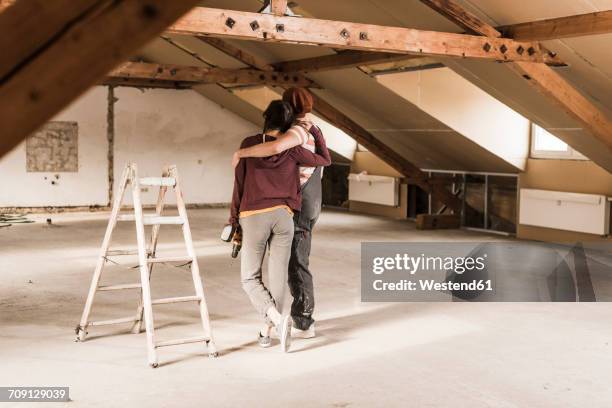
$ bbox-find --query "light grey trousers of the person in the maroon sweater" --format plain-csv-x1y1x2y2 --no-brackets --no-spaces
240,208,294,324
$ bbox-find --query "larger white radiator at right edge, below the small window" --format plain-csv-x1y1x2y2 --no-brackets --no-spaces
519,188,610,235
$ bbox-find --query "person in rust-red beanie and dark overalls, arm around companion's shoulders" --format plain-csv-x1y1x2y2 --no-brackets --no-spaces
233,88,323,338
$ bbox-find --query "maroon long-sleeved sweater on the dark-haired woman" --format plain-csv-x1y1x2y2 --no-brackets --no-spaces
229,127,331,226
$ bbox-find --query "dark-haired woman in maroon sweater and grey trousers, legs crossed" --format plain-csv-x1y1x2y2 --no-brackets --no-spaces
230,101,331,351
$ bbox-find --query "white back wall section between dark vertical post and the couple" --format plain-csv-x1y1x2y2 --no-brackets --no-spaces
114,87,258,204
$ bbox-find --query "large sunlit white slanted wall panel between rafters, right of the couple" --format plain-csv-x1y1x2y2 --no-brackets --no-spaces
376,68,530,170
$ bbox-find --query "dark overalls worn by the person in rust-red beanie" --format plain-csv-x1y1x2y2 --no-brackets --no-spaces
289,167,322,330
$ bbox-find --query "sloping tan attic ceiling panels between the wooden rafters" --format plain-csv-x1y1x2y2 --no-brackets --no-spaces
142,0,612,172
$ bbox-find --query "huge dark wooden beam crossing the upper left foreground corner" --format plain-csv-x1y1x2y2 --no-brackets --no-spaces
0,0,197,156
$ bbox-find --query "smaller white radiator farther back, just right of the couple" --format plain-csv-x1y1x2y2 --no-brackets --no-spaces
348,174,399,207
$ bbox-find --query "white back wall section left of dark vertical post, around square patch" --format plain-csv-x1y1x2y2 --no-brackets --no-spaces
0,87,108,207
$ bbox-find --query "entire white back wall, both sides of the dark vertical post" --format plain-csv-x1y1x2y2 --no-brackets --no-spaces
0,87,258,207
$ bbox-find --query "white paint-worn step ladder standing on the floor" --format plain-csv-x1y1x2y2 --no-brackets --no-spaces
76,163,218,368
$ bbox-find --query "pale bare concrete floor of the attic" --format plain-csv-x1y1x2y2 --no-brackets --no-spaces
0,210,612,408
